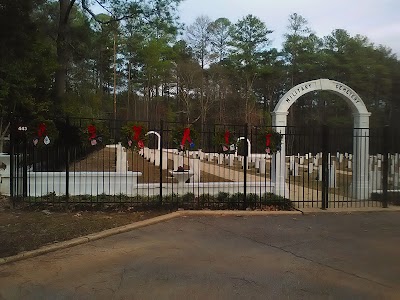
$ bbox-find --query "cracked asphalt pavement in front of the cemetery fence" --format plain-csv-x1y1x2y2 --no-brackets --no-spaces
0,212,400,299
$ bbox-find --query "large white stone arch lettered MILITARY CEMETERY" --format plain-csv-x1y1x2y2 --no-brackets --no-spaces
272,79,371,199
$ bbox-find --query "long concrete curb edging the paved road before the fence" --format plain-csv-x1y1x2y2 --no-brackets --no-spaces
0,207,400,265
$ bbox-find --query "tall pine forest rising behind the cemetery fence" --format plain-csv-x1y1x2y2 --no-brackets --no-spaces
0,0,400,136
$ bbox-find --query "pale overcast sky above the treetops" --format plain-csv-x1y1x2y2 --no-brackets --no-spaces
179,0,400,58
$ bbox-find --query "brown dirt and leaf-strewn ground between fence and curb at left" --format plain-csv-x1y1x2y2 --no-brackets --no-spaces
0,198,167,257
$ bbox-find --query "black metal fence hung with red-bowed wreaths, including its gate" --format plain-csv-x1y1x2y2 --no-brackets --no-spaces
7,118,400,210
